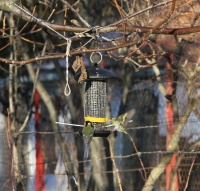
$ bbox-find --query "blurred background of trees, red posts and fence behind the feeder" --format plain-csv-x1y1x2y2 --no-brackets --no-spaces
0,0,200,191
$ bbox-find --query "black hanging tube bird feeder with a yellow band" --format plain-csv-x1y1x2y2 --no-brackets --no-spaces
75,52,117,137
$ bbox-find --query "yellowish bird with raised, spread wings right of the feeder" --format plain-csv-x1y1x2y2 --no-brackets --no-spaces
111,109,135,134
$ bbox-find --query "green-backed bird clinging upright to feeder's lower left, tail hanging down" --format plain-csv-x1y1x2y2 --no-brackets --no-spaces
82,121,94,158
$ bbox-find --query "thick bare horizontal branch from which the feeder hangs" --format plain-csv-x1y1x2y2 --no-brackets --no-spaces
0,0,200,36
